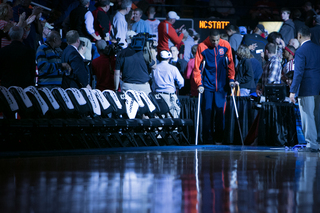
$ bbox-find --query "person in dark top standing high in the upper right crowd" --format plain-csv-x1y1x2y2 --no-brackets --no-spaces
279,8,295,45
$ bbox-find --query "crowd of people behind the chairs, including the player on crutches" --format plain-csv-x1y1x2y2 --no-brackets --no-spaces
0,0,320,146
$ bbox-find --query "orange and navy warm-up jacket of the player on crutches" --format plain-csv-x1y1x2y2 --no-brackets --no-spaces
193,37,235,91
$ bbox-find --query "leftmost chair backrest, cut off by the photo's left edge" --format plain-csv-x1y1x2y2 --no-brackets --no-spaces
0,86,19,118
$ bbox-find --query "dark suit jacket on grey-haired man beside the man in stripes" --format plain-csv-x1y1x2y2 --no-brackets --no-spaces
61,45,90,89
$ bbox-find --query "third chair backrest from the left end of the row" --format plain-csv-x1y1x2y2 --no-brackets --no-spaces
24,86,49,118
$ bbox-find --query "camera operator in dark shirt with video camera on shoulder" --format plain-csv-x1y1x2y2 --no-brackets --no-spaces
114,34,156,94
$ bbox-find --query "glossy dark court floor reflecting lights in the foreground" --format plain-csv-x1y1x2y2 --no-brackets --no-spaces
0,146,320,213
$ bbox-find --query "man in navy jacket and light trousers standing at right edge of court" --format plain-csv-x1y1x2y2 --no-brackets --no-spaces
290,26,320,152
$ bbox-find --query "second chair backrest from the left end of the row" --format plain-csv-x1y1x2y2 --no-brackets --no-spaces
9,86,34,118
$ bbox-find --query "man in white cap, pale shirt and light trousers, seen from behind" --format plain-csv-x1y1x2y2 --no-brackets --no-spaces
152,50,184,118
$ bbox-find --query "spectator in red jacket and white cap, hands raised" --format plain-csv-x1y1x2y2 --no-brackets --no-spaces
158,11,186,53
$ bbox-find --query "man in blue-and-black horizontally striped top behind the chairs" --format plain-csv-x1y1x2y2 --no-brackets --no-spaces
36,31,71,89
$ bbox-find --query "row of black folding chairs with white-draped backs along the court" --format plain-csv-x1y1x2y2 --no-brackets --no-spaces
0,86,193,150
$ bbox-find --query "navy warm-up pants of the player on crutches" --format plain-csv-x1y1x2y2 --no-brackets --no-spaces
201,89,227,143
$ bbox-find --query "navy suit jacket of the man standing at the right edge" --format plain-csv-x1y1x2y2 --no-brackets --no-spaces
290,41,320,96
